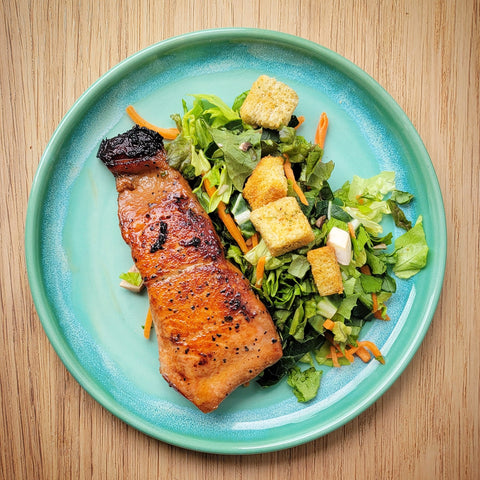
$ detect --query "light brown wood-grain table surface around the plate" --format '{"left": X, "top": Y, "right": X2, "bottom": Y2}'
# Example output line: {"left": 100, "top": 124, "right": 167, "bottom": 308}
{"left": 0, "top": 0, "right": 480, "bottom": 480}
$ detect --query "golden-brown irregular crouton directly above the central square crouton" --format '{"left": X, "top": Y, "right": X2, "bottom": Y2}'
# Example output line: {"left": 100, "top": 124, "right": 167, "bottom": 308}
{"left": 243, "top": 155, "right": 288, "bottom": 210}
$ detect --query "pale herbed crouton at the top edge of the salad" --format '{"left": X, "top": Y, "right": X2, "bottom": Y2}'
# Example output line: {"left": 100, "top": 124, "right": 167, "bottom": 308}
{"left": 240, "top": 75, "right": 298, "bottom": 130}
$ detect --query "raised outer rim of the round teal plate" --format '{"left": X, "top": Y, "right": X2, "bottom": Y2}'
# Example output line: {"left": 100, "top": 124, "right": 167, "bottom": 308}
{"left": 24, "top": 27, "right": 447, "bottom": 454}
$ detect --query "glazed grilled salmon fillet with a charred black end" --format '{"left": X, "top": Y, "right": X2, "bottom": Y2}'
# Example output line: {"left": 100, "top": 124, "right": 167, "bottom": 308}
{"left": 97, "top": 126, "right": 282, "bottom": 413}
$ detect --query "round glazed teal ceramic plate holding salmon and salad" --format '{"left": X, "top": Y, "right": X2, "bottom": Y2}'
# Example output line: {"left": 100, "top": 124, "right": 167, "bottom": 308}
{"left": 26, "top": 29, "right": 446, "bottom": 454}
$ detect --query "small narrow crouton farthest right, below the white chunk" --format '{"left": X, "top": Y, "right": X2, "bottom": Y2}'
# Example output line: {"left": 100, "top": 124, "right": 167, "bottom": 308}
{"left": 307, "top": 246, "right": 343, "bottom": 297}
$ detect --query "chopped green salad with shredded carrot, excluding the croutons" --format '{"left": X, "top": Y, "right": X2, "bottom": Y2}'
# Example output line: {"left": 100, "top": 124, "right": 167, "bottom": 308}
{"left": 123, "top": 86, "right": 428, "bottom": 402}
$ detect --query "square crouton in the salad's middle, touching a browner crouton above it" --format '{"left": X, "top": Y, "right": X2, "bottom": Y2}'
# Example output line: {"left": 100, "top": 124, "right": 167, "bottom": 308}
{"left": 250, "top": 197, "right": 315, "bottom": 257}
